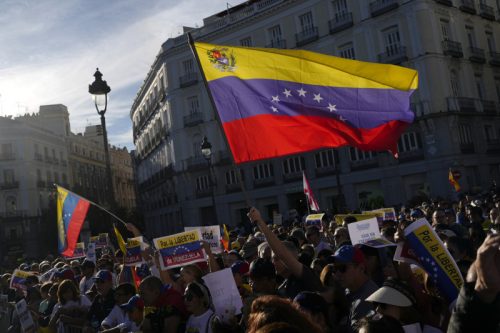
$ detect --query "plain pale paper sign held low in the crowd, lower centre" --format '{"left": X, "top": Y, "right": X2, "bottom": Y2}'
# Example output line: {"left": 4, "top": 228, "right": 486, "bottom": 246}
{"left": 203, "top": 268, "right": 243, "bottom": 321}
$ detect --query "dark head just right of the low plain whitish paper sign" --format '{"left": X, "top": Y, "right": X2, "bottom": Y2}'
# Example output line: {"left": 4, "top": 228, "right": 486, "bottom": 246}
{"left": 249, "top": 258, "right": 277, "bottom": 294}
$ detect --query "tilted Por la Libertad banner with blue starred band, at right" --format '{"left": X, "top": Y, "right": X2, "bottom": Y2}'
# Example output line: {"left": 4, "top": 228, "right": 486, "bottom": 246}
{"left": 404, "top": 219, "right": 464, "bottom": 303}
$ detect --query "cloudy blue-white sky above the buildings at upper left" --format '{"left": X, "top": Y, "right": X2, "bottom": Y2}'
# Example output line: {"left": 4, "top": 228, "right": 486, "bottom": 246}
{"left": 0, "top": 0, "right": 237, "bottom": 150}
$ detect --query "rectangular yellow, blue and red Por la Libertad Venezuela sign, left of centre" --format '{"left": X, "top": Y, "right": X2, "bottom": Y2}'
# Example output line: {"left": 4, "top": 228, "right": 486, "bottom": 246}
{"left": 153, "top": 230, "right": 206, "bottom": 270}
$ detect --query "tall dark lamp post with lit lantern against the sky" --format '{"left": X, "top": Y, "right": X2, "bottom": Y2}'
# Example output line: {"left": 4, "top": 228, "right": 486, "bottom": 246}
{"left": 89, "top": 68, "right": 116, "bottom": 208}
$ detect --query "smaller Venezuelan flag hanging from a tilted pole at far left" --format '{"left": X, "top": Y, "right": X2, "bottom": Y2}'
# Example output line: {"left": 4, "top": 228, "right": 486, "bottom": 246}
{"left": 57, "top": 186, "right": 90, "bottom": 257}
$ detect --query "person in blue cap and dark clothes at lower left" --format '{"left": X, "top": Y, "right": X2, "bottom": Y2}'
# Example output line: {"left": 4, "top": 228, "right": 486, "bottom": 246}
{"left": 87, "top": 270, "right": 115, "bottom": 330}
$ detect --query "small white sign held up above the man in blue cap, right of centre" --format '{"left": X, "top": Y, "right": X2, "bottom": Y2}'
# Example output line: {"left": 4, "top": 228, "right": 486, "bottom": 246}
{"left": 347, "top": 217, "right": 396, "bottom": 248}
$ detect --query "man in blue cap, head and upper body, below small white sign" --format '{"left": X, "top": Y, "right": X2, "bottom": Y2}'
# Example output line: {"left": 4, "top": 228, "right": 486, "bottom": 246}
{"left": 331, "top": 245, "right": 378, "bottom": 328}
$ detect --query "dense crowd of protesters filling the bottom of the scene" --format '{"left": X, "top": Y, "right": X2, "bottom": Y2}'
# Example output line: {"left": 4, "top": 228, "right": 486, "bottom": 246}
{"left": 0, "top": 188, "right": 500, "bottom": 333}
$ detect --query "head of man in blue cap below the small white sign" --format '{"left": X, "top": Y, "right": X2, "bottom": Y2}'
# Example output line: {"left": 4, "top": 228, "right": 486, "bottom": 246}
{"left": 332, "top": 245, "right": 368, "bottom": 292}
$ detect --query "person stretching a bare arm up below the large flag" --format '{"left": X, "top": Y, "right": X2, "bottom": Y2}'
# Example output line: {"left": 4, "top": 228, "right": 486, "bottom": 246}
{"left": 248, "top": 207, "right": 323, "bottom": 299}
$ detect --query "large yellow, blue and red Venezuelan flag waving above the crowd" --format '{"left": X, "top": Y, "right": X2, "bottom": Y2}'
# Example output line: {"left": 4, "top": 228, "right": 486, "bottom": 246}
{"left": 194, "top": 42, "right": 418, "bottom": 163}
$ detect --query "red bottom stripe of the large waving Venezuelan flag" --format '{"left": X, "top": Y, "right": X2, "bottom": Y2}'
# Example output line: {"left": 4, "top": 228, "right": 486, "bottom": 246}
{"left": 223, "top": 115, "right": 409, "bottom": 163}
